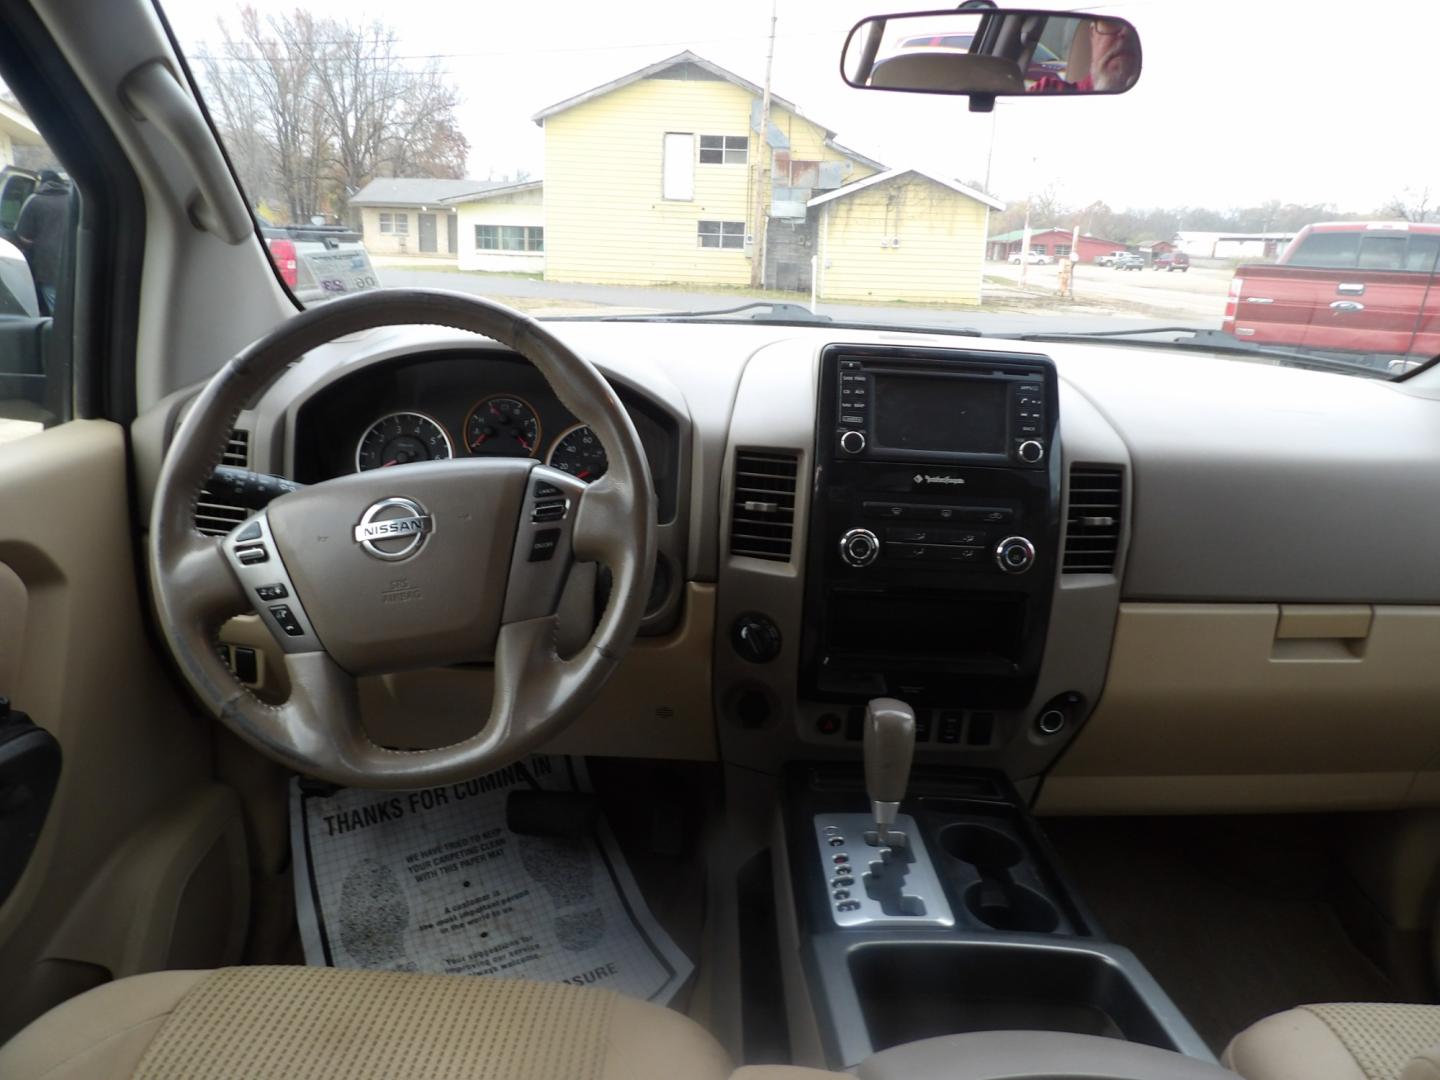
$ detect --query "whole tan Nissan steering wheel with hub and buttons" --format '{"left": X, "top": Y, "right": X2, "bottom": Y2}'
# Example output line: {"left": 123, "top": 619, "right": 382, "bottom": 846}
{"left": 150, "top": 289, "right": 655, "bottom": 788}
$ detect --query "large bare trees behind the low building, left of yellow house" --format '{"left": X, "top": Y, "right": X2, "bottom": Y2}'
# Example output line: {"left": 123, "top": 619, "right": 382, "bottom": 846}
{"left": 200, "top": 7, "right": 469, "bottom": 222}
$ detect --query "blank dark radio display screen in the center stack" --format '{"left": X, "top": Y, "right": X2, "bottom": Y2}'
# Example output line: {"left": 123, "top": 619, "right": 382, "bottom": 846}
{"left": 873, "top": 373, "right": 1009, "bottom": 454}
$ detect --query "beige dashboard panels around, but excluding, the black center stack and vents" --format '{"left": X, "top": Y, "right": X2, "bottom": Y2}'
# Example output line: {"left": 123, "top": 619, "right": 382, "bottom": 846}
{"left": 135, "top": 323, "right": 1440, "bottom": 814}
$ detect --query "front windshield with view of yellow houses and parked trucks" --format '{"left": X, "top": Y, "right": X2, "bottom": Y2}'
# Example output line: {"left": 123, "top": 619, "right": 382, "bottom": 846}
{"left": 164, "top": 0, "right": 1440, "bottom": 376}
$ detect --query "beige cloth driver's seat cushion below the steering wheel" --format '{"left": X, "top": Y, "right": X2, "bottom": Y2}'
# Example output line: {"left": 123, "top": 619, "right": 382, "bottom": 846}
{"left": 0, "top": 966, "right": 835, "bottom": 1080}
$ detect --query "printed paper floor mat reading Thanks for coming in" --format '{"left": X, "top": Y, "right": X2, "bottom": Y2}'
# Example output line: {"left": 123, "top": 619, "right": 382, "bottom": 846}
{"left": 291, "top": 756, "right": 694, "bottom": 1004}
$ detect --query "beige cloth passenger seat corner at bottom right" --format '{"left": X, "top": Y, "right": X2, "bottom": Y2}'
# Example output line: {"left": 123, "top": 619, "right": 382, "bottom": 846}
{"left": 1223, "top": 1002, "right": 1440, "bottom": 1080}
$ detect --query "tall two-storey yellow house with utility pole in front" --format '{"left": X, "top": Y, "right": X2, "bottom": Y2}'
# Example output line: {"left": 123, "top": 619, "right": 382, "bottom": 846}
{"left": 534, "top": 52, "right": 883, "bottom": 288}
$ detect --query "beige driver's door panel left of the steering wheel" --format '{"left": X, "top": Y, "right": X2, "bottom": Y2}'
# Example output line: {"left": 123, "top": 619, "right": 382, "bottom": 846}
{"left": 0, "top": 420, "right": 249, "bottom": 1041}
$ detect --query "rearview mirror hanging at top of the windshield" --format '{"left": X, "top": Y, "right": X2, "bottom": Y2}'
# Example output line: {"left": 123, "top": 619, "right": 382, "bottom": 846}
{"left": 840, "top": 7, "right": 1140, "bottom": 111}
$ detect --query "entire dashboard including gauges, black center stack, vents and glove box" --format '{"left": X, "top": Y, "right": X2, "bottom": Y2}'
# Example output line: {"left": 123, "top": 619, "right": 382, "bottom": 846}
{"left": 135, "top": 323, "right": 1440, "bottom": 814}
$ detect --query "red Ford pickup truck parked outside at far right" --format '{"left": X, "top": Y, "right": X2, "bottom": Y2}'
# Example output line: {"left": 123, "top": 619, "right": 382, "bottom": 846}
{"left": 1220, "top": 222, "right": 1440, "bottom": 363}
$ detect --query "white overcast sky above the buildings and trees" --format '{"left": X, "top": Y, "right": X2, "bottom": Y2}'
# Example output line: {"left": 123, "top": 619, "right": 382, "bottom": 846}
{"left": 163, "top": 0, "right": 1440, "bottom": 212}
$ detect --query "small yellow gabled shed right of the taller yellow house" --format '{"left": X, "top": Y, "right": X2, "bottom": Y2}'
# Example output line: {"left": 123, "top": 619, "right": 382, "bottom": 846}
{"left": 808, "top": 168, "right": 1005, "bottom": 305}
